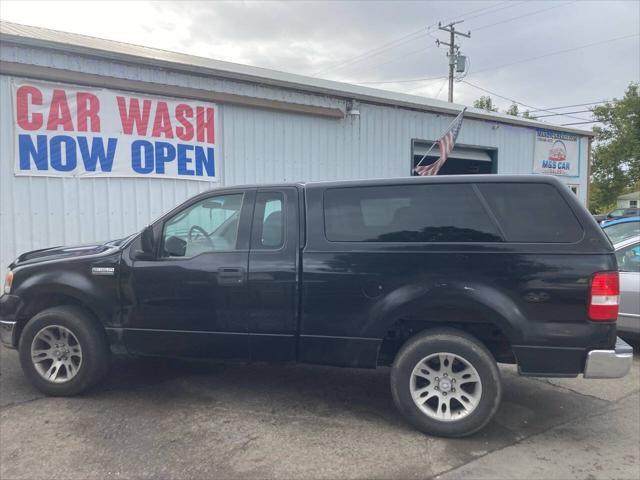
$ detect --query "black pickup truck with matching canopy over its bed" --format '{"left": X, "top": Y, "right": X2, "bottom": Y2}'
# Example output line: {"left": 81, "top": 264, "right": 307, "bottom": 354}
{"left": 0, "top": 175, "right": 632, "bottom": 436}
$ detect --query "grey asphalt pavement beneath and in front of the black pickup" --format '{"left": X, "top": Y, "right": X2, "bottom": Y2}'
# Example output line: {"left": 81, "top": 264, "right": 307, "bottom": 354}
{"left": 0, "top": 348, "right": 640, "bottom": 480}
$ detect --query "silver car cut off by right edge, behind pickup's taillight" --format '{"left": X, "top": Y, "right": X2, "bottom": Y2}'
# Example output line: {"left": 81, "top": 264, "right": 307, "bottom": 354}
{"left": 615, "top": 235, "right": 640, "bottom": 341}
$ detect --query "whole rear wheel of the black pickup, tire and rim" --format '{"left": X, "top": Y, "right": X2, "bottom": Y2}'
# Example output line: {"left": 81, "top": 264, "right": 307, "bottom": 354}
{"left": 391, "top": 329, "right": 502, "bottom": 437}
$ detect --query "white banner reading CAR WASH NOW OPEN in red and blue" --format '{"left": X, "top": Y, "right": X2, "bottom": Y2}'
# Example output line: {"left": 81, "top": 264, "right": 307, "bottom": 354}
{"left": 12, "top": 80, "right": 217, "bottom": 181}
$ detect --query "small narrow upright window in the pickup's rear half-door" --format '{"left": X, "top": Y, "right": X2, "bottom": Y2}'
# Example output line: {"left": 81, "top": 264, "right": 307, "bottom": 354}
{"left": 251, "top": 192, "right": 284, "bottom": 250}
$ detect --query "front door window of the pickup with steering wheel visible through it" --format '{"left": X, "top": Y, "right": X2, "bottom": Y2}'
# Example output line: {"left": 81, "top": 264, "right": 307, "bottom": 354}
{"left": 162, "top": 193, "right": 243, "bottom": 257}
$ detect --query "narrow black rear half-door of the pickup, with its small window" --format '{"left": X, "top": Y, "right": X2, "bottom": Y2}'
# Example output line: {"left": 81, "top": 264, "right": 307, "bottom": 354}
{"left": 247, "top": 187, "right": 300, "bottom": 361}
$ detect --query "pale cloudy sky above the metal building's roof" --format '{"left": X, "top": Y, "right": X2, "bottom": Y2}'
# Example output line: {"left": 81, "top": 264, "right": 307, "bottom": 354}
{"left": 0, "top": 0, "right": 640, "bottom": 127}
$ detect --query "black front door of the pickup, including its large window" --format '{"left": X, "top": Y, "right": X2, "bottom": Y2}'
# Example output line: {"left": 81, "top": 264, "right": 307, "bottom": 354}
{"left": 123, "top": 189, "right": 255, "bottom": 359}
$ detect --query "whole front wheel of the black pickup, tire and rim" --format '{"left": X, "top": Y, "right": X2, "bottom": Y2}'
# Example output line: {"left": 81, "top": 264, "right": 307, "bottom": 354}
{"left": 18, "top": 305, "right": 110, "bottom": 396}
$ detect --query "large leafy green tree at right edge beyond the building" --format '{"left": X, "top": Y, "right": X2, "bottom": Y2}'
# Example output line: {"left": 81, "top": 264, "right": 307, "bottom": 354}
{"left": 589, "top": 83, "right": 640, "bottom": 212}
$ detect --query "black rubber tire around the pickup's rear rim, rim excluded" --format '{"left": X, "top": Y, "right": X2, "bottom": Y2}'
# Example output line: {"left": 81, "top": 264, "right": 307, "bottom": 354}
{"left": 391, "top": 329, "right": 502, "bottom": 437}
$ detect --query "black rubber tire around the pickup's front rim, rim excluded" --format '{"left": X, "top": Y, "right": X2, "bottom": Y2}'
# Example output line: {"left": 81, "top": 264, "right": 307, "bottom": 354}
{"left": 18, "top": 305, "right": 111, "bottom": 396}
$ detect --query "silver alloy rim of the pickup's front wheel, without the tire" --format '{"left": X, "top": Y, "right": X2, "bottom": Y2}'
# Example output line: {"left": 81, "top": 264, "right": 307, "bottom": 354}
{"left": 31, "top": 325, "right": 82, "bottom": 383}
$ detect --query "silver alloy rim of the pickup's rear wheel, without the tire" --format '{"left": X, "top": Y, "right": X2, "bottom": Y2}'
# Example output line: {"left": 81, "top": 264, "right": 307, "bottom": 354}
{"left": 409, "top": 352, "right": 482, "bottom": 422}
